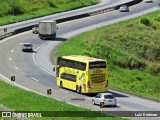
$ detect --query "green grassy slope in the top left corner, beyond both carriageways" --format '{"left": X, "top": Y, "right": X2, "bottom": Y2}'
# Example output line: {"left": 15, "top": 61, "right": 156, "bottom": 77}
{"left": 0, "top": 0, "right": 98, "bottom": 25}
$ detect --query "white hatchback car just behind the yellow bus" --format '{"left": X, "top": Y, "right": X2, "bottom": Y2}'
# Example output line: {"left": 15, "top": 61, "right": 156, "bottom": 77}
{"left": 92, "top": 93, "right": 117, "bottom": 107}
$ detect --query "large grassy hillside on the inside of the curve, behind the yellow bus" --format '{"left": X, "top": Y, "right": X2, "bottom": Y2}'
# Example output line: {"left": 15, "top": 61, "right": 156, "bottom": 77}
{"left": 55, "top": 11, "right": 160, "bottom": 100}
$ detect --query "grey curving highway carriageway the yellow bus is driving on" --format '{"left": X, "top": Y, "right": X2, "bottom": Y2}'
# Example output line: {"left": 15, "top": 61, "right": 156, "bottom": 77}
{"left": 0, "top": 1, "right": 160, "bottom": 119}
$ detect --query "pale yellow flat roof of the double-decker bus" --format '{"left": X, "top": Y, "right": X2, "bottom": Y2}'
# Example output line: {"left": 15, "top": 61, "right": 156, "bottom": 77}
{"left": 62, "top": 55, "right": 106, "bottom": 63}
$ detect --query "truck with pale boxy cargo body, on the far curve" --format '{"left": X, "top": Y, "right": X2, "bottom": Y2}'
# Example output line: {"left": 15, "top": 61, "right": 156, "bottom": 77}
{"left": 39, "top": 20, "right": 58, "bottom": 39}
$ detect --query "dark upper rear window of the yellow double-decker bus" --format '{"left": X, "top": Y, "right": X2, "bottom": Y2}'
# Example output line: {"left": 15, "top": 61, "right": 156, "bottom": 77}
{"left": 89, "top": 61, "right": 106, "bottom": 69}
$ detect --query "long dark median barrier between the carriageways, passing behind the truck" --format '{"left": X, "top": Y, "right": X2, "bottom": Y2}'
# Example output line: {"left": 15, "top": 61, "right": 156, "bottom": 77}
{"left": 0, "top": 0, "right": 143, "bottom": 40}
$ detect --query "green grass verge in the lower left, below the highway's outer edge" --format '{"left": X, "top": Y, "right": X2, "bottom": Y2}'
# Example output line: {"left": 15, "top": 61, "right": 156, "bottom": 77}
{"left": 0, "top": 80, "right": 124, "bottom": 120}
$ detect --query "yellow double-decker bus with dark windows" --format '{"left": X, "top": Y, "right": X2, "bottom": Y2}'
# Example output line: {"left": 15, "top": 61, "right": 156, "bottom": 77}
{"left": 53, "top": 55, "right": 108, "bottom": 94}
